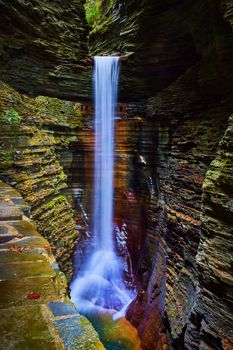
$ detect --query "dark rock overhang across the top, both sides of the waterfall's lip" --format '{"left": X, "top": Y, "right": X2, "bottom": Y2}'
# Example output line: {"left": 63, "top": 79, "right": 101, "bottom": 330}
{"left": 0, "top": 0, "right": 232, "bottom": 101}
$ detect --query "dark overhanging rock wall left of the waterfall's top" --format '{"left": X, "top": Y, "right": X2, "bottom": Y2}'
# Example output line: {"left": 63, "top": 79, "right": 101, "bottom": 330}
{"left": 0, "top": 0, "right": 91, "bottom": 100}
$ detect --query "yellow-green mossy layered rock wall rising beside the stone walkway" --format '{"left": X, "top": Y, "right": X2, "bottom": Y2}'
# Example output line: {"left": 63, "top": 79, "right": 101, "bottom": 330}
{"left": 0, "top": 83, "right": 82, "bottom": 276}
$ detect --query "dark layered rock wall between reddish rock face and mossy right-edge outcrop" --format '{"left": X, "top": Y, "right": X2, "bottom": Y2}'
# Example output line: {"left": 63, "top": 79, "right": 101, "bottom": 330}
{"left": 144, "top": 39, "right": 232, "bottom": 349}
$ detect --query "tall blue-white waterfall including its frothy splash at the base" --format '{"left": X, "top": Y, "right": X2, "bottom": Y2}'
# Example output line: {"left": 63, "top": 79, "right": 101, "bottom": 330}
{"left": 70, "top": 57, "right": 133, "bottom": 318}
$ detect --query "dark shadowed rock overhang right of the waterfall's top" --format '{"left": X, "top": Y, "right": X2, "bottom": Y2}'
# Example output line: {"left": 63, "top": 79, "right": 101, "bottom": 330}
{"left": 89, "top": 0, "right": 232, "bottom": 101}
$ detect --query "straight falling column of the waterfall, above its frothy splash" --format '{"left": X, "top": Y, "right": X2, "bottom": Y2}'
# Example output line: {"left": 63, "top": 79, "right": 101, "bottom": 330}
{"left": 94, "top": 57, "right": 119, "bottom": 252}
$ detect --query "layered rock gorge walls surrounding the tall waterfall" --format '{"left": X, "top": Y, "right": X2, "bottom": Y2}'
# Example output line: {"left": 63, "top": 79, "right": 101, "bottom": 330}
{"left": 0, "top": 0, "right": 233, "bottom": 350}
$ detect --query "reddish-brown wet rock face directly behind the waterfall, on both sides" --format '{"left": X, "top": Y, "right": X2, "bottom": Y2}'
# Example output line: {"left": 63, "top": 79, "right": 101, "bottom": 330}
{"left": 65, "top": 105, "right": 169, "bottom": 349}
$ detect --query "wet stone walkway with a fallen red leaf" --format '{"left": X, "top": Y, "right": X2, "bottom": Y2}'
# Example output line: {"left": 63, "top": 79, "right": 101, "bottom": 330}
{"left": 0, "top": 181, "right": 105, "bottom": 350}
